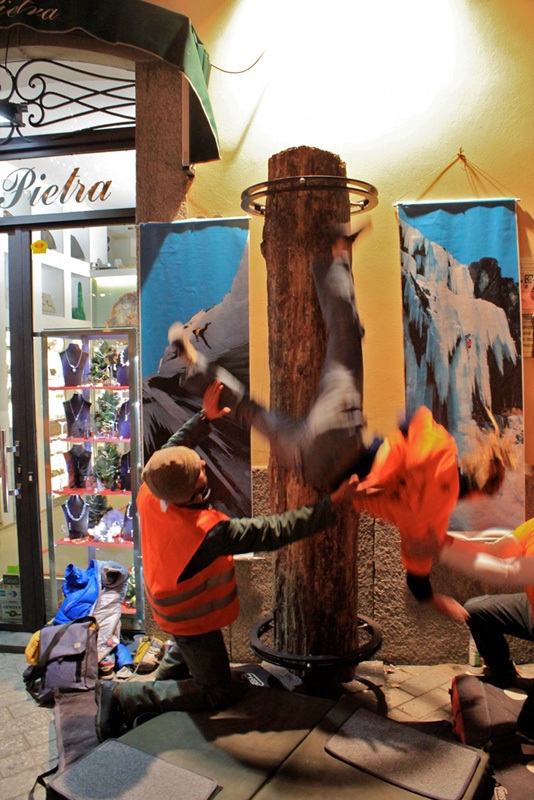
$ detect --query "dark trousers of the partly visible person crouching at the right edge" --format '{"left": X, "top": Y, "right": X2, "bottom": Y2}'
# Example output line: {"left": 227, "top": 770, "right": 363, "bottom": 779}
{"left": 465, "top": 592, "right": 534, "bottom": 739}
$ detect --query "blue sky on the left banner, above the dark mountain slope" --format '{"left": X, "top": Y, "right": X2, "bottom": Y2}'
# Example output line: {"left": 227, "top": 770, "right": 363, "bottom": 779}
{"left": 140, "top": 217, "right": 249, "bottom": 376}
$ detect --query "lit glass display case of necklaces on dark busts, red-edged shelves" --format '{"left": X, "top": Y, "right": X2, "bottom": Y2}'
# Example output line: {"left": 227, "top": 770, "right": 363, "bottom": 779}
{"left": 41, "top": 328, "right": 144, "bottom": 619}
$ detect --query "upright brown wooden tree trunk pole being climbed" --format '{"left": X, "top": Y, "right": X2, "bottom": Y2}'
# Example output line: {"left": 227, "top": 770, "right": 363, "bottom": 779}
{"left": 262, "top": 147, "right": 364, "bottom": 682}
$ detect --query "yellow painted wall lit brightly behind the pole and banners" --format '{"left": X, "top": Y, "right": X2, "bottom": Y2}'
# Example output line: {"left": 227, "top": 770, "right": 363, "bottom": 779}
{"left": 148, "top": 0, "right": 534, "bottom": 466}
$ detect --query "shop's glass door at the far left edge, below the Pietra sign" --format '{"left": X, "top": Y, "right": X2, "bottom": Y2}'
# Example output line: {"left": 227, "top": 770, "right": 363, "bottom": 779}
{"left": 0, "top": 229, "right": 45, "bottom": 630}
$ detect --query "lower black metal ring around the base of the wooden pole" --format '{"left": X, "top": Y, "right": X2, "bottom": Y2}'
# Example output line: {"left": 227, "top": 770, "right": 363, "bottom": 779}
{"left": 249, "top": 614, "right": 382, "bottom": 671}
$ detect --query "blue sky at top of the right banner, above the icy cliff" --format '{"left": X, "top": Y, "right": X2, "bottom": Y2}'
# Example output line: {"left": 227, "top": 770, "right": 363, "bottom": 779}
{"left": 398, "top": 200, "right": 519, "bottom": 281}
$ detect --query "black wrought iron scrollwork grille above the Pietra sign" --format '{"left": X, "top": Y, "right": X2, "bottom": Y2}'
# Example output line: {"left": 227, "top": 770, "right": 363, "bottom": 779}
{"left": 0, "top": 59, "right": 135, "bottom": 146}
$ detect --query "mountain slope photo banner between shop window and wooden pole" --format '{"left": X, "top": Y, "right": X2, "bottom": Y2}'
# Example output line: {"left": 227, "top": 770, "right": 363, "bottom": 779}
{"left": 140, "top": 217, "right": 251, "bottom": 516}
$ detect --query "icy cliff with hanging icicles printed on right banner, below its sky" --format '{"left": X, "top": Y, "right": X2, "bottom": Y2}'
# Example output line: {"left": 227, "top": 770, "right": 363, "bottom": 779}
{"left": 399, "top": 220, "right": 524, "bottom": 530}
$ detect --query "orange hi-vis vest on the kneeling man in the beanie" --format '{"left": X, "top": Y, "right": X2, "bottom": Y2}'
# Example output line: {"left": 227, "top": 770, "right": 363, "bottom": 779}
{"left": 137, "top": 484, "right": 239, "bottom": 636}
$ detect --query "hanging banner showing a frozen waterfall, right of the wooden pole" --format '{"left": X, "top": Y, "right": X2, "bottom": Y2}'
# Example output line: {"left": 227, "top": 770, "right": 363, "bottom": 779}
{"left": 397, "top": 199, "right": 525, "bottom": 530}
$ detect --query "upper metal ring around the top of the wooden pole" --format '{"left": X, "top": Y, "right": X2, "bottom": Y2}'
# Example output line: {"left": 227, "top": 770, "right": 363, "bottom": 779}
{"left": 241, "top": 175, "right": 378, "bottom": 216}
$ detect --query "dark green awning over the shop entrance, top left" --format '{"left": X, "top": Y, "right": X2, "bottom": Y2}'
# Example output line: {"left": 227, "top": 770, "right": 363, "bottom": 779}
{"left": 0, "top": 0, "right": 220, "bottom": 163}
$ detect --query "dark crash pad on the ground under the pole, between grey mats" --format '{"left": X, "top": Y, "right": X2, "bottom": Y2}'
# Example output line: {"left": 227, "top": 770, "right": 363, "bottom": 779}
{"left": 120, "top": 687, "right": 488, "bottom": 800}
